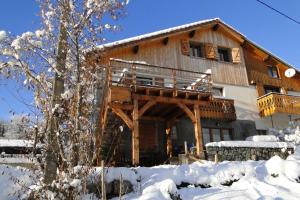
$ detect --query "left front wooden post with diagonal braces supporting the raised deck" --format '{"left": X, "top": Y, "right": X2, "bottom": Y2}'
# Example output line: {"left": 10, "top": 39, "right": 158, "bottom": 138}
{"left": 132, "top": 99, "right": 140, "bottom": 166}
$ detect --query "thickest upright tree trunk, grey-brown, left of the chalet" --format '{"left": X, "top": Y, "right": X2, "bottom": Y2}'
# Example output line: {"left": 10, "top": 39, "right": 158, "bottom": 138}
{"left": 44, "top": 1, "right": 70, "bottom": 184}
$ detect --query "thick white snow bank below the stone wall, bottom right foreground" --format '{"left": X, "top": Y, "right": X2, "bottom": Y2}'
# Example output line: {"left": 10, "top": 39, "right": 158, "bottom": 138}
{"left": 108, "top": 156, "right": 300, "bottom": 200}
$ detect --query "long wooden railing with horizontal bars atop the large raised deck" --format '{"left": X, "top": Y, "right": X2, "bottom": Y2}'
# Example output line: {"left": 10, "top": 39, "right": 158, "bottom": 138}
{"left": 109, "top": 59, "right": 212, "bottom": 93}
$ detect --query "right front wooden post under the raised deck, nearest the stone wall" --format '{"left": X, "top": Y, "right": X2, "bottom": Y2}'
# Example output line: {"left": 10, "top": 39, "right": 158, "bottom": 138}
{"left": 194, "top": 105, "right": 203, "bottom": 157}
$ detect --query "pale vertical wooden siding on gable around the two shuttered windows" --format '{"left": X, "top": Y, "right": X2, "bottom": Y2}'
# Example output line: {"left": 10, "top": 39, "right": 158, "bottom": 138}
{"left": 102, "top": 29, "right": 248, "bottom": 86}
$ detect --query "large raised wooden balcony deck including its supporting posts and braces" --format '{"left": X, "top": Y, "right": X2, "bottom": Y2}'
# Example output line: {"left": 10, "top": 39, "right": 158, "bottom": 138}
{"left": 97, "top": 60, "right": 236, "bottom": 165}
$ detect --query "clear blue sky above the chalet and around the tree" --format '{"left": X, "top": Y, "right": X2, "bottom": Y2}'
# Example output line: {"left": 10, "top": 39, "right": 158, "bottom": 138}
{"left": 0, "top": 0, "right": 300, "bottom": 119}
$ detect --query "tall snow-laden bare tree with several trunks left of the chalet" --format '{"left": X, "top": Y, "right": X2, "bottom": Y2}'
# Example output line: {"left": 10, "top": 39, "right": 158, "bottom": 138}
{"left": 0, "top": 0, "right": 128, "bottom": 184}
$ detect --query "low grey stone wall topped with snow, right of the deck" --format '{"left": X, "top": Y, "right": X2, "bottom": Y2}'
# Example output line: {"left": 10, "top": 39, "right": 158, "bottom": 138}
{"left": 206, "top": 146, "right": 294, "bottom": 161}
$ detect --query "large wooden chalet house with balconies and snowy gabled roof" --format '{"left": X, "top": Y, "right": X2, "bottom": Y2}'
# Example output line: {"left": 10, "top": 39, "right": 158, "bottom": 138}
{"left": 88, "top": 18, "right": 300, "bottom": 165}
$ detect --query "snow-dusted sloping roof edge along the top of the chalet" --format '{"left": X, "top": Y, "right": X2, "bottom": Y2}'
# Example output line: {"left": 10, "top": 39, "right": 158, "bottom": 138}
{"left": 92, "top": 18, "right": 299, "bottom": 72}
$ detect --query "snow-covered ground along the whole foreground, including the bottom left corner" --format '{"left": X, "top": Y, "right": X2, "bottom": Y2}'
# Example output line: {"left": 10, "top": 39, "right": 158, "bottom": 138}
{"left": 0, "top": 151, "right": 300, "bottom": 200}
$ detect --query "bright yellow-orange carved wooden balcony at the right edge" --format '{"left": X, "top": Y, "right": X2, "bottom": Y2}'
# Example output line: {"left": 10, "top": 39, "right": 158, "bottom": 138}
{"left": 257, "top": 93, "right": 300, "bottom": 117}
